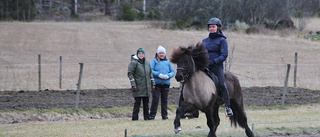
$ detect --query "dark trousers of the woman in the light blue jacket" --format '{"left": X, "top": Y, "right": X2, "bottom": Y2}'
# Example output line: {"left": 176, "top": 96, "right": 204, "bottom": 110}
{"left": 150, "top": 84, "right": 169, "bottom": 118}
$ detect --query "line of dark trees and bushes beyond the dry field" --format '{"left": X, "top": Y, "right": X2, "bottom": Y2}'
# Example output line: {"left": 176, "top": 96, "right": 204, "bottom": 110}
{"left": 0, "top": 0, "right": 320, "bottom": 28}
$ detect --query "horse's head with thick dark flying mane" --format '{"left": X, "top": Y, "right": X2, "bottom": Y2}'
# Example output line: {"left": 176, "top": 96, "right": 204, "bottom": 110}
{"left": 170, "top": 43, "right": 208, "bottom": 83}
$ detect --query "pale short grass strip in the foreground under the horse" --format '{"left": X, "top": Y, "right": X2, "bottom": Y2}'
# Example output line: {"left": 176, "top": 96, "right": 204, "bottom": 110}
{"left": 0, "top": 104, "right": 320, "bottom": 137}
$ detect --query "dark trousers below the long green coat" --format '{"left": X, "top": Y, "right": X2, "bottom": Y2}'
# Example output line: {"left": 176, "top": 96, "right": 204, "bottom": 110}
{"left": 132, "top": 97, "right": 149, "bottom": 120}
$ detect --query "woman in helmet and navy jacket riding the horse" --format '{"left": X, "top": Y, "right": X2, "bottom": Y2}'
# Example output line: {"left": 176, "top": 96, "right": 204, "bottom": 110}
{"left": 202, "top": 18, "right": 233, "bottom": 117}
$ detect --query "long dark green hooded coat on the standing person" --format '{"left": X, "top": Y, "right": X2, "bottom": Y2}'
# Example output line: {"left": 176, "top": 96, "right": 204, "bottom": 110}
{"left": 128, "top": 54, "right": 155, "bottom": 97}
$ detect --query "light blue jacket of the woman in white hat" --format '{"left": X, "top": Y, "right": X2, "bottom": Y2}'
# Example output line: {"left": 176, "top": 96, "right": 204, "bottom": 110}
{"left": 150, "top": 58, "right": 175, "bottom": 86}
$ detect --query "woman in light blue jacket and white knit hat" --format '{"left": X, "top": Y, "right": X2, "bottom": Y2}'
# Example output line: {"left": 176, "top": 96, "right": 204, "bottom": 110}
{"left": 150, "top": 45, "right": 175, "bottom": 120}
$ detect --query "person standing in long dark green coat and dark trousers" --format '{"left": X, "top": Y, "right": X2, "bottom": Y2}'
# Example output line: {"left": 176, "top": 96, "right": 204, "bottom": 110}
{"left": 128, "top": 48, "right": 155, "bottom": 121}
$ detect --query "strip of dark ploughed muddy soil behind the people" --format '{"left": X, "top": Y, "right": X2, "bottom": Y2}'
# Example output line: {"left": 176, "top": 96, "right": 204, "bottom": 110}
{"left": 0, "top": 87, "right": 320, "bottom": 110}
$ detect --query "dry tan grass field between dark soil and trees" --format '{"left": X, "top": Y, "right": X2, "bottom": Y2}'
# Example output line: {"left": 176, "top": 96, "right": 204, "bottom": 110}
{"left": 0, "top": 19, "right": 320, "bottom": 91}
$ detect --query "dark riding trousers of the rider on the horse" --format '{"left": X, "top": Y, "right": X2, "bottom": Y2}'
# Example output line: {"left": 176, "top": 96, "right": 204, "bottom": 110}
{"left": 209, "top": 66, "right": 230, "bottom": 107}
